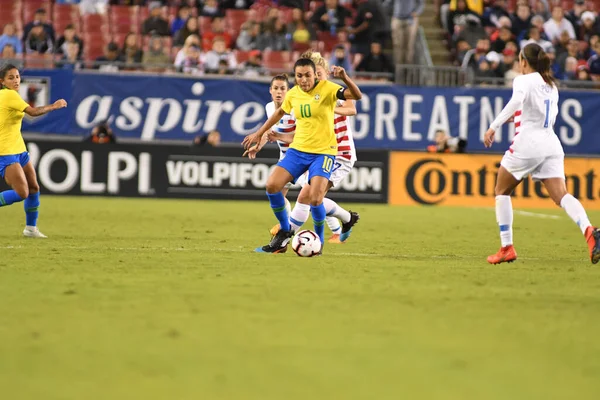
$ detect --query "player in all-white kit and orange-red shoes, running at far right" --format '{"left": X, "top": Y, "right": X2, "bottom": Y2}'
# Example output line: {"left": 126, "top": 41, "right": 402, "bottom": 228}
{"left": 484, "top": 43, "right": 600, "bottom": 264}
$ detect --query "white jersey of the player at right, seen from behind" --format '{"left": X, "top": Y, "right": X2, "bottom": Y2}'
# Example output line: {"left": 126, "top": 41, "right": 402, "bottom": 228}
{"left": 490, "top": 72, "right": 564, "bottom": 158}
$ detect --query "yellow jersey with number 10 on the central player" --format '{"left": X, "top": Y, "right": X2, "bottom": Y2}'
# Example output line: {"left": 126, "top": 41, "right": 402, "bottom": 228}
{"left": 281, "top": 81, "right": 342, "bottom": 156}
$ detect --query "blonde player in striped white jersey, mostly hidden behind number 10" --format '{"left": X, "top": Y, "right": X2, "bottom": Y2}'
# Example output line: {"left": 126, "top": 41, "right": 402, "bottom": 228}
{"left": 269, "top": 51, "right": 360, "bottom": 243}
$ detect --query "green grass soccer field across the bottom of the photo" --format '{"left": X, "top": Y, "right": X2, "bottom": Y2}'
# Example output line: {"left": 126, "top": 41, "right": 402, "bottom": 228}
{"left": 0, "top": 197, "right": 600, "bottom": 400}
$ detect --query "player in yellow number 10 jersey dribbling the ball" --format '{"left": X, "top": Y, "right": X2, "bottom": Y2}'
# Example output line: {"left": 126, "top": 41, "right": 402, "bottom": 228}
{"left": 242, "top": 58, "right": 362, "bottom": 253}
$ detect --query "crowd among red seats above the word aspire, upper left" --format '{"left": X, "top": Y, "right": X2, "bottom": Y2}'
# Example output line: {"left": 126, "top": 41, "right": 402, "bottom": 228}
{"left": 0, "top": 0, "right": 403, "bottom": 76}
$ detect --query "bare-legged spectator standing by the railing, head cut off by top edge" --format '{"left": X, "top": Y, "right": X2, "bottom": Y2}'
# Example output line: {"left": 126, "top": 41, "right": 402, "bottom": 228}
{"left": 392, "top": 0, "right": 425, "bottom": 64}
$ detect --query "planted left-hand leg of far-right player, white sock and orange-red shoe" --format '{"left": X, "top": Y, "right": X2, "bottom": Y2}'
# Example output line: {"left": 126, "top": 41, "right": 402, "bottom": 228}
{"left": 487, "top": 166, "right": 520, "bottom": 264}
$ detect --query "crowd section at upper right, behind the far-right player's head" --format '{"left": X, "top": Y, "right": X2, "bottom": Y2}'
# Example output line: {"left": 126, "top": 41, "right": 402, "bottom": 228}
{"left": 438, "top": 0, "right": 600, "bottom": 86}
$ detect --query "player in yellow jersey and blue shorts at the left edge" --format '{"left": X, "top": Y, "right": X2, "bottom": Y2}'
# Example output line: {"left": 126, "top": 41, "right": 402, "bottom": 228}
{"left": 0, "top": 64, "right": 67, "bottom": 238}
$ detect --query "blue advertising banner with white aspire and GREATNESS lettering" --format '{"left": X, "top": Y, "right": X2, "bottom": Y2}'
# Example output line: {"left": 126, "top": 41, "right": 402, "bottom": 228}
{"left": 21, "top": 71, "right": 600, "bottom": 154}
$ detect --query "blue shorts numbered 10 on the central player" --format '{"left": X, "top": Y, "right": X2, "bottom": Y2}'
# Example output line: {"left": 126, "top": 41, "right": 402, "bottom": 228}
{"left": 277, "top": 149, "right": 335, "bottom": 182}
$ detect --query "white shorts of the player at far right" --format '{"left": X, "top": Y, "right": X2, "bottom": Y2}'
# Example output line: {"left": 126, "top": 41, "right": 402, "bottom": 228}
{"left": 500, "top": 151, "right": 565, "bottom": 181}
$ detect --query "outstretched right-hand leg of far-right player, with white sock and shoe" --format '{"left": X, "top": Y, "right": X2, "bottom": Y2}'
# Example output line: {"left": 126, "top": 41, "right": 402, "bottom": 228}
{"left": 542, "top": 178, "right": 600, "bottom": 264}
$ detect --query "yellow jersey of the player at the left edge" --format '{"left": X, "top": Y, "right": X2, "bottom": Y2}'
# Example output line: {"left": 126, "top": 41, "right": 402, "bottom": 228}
{"left": 0, "top": 89, "right": 29, "bottom": 156}
